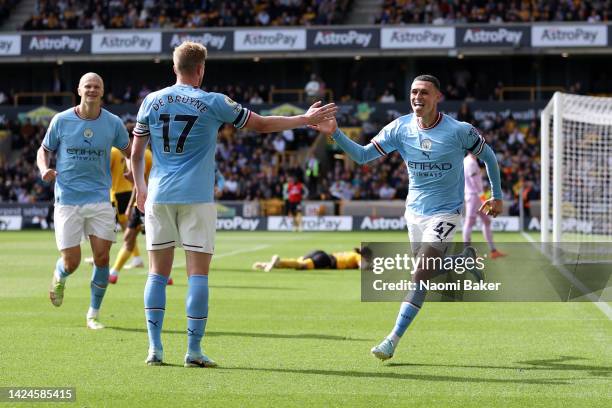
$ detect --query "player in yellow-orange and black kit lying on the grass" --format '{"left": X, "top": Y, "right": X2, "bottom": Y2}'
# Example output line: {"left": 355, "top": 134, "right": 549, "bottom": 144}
{"left": 253, "top": 248, "right": 361, "bottom": 272}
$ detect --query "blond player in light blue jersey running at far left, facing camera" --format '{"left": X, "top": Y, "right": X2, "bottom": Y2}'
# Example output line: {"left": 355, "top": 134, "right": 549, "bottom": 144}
{"left": 37, "top": 72, "right": 130, "bottom": 330}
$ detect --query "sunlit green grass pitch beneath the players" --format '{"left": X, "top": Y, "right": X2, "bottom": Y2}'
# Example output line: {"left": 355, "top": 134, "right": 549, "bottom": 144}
{"left": 0, "top": 232, "right": 612, "bottom": 408}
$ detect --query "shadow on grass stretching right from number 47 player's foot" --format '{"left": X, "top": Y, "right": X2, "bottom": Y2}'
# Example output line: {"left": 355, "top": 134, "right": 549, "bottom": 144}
{"left": 387, "top": 356, "right": 612, "bottom": 377}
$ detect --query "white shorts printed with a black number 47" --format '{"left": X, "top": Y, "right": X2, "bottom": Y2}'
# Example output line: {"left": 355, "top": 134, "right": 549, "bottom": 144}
{"left": 404, "top": 210, "right": 461, "bottom": 254}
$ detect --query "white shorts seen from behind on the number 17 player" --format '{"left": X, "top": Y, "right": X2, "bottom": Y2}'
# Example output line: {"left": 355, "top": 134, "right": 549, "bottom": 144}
{"left": 144, "top": 203, "right": 217, "bottom": 254}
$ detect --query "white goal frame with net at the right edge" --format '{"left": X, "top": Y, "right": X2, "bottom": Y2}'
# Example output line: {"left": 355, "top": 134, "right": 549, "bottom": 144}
{"left": 540, "top": 92, "right": 612, "bottom": 243}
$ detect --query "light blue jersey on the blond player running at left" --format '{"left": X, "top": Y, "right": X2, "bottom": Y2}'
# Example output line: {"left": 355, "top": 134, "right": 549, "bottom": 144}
{"left": 42, "top": 108, "right": 130, "bottom": 205}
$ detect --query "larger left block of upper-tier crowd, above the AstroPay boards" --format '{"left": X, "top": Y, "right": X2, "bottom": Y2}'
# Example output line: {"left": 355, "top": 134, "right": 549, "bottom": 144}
{"left": 23, "top": 0, "right": 350, "bottom": 30}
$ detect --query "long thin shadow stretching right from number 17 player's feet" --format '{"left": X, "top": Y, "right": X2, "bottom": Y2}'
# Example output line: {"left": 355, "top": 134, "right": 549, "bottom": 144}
{"left": 217, "top": 367, "right": 570, "bottom": 385}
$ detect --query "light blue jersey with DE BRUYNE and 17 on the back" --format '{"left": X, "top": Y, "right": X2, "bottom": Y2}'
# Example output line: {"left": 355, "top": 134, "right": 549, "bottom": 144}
{"left": 134, "top": 84, "right": 251, "bottom": 204}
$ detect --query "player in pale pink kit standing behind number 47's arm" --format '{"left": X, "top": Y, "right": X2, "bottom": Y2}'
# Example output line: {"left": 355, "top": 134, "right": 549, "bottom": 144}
{"left": 463, "top": 153, "right": 506, "bottom": 259}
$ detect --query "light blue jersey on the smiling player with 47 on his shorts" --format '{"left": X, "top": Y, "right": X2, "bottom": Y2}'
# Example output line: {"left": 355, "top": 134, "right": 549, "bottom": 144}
{"left": 372, "top": 113, "right": 486, "bottom": 215}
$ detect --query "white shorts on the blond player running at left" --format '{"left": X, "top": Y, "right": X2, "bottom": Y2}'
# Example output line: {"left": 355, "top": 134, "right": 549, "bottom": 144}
{"left": 53, "top": 202, "right": 117, "bottom": 251}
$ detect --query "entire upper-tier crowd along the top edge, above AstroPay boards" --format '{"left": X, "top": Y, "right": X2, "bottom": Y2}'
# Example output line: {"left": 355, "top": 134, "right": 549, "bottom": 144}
{"left": 19, "top": 0, "right": 612, "bottom": 30}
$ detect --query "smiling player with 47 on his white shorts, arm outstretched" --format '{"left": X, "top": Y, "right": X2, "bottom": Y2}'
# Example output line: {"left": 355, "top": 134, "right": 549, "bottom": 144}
{"left": 313, "top": 75, "right": 502, "bottom": 360}
